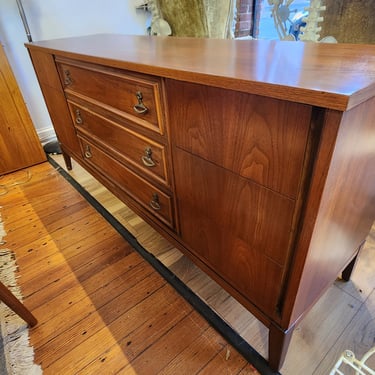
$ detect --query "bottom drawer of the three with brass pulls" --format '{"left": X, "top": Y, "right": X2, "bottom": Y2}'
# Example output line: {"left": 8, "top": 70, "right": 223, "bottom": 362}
{"left": 79, "top": 136, "right": 174, "bottom": 229}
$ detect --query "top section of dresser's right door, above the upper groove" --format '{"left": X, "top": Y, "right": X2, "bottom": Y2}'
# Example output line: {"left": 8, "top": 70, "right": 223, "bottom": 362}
{"left": 166, "top": 80, "right": 311, "bottom": 198}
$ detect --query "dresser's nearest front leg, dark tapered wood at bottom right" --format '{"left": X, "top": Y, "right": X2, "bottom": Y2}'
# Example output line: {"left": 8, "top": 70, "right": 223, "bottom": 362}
{"left": 268, "top": 323, "right": 294, "bottom": 371}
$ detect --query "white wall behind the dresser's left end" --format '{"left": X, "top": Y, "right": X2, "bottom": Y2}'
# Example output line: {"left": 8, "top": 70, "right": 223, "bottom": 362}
{"left": 0, "top": 0, "right": 150, "bottom": 142}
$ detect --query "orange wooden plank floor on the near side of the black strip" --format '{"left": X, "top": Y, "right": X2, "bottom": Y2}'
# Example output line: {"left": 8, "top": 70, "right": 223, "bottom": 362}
{"left": 0, "top": 163, "right": 257, "bottom": 375}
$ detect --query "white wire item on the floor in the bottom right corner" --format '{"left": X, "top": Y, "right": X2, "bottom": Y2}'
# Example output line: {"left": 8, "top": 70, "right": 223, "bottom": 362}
{"left": 329, "top": 346, "right": 375, "bottom": 375}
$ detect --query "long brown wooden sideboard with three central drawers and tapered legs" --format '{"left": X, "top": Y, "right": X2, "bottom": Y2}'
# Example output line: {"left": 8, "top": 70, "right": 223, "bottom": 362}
{"left": 27, "top": 35, "right": 375, "bottom": 369}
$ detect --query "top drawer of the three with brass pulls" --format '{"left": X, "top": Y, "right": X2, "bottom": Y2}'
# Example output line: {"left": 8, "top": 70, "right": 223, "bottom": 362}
{"left": 56, "top": 58, "right": 164, "bottom": 134}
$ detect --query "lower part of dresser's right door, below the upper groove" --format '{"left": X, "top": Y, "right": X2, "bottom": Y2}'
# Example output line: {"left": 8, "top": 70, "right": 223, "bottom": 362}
{"left": 174, "top": 149, "right": 294, "bottom": 314}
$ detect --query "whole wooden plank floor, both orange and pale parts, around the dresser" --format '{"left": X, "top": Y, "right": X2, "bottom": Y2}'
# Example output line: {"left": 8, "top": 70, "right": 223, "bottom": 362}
{"left": 0, "top": 155, "right": 375, "bottom": 375}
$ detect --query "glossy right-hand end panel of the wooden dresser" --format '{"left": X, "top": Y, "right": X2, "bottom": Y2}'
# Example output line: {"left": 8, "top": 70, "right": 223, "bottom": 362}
{"left": 286, "top": 99, "right": 375, "bottom": 328}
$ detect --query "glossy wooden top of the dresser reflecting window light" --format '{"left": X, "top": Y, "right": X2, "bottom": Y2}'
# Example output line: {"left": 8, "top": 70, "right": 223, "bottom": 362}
{"left": 26, "top": 34, "right": 375, "bottom": 110}
